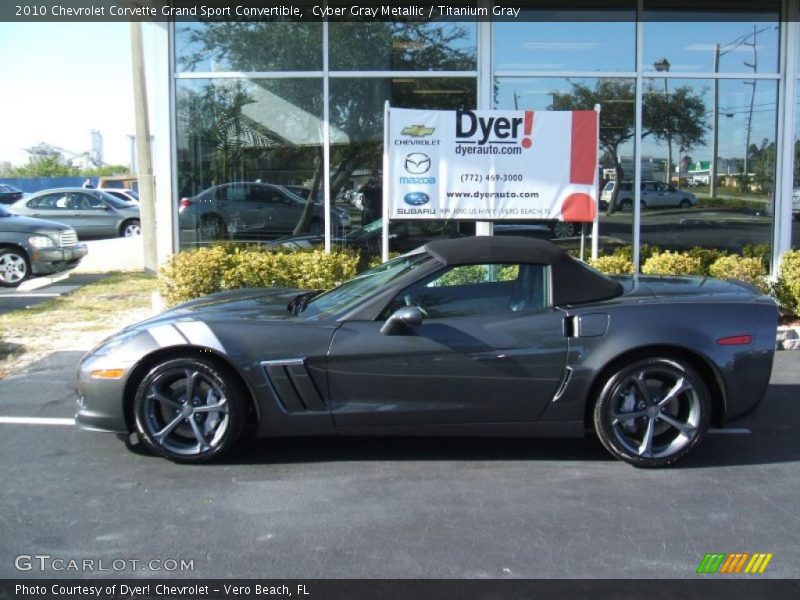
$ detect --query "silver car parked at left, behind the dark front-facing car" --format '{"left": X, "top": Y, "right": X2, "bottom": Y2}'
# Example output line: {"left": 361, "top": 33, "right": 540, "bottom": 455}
{"left": 9, "top": 188, "right": 141, "bottom": 238}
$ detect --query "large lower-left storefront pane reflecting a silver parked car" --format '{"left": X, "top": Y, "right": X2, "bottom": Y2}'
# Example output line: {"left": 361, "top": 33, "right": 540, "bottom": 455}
{"left": 176, "top": 79, "right": 324, "bottom": 248}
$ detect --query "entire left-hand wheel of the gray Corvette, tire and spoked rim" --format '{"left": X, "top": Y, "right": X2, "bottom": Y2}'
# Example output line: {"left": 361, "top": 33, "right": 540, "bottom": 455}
{"left": 133, "top": 357, "right": 247, "bottom": 463}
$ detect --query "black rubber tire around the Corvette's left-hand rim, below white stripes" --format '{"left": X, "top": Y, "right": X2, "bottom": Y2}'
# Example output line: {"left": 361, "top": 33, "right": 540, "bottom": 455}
{"left": 133, "top": 357, "right": 246, "bottom": 463}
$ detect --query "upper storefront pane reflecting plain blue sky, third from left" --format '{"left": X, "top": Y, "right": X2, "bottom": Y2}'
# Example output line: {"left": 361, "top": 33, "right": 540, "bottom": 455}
{"left": 492, "top": 4, "right": 636, "bottom": 72}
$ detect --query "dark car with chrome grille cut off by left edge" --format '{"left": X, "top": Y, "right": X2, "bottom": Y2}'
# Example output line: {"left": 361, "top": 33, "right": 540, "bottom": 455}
{"left": 0, "top": 206, "right": 86, "bottom": 287}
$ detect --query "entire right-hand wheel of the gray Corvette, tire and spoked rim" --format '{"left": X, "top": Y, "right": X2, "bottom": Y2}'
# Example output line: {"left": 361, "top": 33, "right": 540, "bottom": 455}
{"left": 594, "top": 356, "right": 711, "bottom": 468}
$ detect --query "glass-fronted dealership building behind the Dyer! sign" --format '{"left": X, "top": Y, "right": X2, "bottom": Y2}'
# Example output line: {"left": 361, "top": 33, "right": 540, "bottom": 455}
{"left": 144, "top": 0, "right": 800, "bottom": 272}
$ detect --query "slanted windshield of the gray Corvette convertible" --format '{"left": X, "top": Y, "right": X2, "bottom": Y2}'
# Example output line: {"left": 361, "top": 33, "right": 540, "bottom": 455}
{"left": 302, "top": 251, "right": 431, "bottom": 318}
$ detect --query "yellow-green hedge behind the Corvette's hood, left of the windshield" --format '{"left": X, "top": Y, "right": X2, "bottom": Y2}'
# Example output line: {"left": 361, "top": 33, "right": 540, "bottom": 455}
{"left": 160, "top": 244, "right": 359, "bottom": 306}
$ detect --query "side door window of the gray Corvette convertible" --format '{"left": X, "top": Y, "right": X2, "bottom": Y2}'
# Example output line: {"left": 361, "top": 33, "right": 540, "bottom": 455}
{"left": 382, "top": 264, "right": 549, "bottom": 319}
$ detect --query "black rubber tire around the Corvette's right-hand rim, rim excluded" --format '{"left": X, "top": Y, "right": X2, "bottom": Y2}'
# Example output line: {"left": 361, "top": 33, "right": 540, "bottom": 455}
{"left": 594, "top": 356, "right": 711, "bottom": 468}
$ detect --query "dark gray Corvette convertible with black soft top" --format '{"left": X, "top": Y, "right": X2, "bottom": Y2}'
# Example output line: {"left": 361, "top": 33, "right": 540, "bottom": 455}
{"left": 76, "top": 237, "right": 778, "bottom": 467}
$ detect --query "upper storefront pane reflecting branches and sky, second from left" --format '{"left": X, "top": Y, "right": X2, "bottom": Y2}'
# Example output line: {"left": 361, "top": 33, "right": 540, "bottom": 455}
{"left": 329, "top": 22, "right": 478, "bottom": 71}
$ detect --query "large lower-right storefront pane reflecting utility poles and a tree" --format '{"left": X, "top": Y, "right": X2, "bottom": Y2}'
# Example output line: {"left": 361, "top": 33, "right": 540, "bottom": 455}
{"left": 641, "top": 78, "right": 778, "bottom": 254}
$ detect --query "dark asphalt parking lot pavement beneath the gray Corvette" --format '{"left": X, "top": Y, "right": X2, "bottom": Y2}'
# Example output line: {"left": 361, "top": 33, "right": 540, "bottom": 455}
{"left": 0, "top": 352, "right": 800, "bottom": 578}
